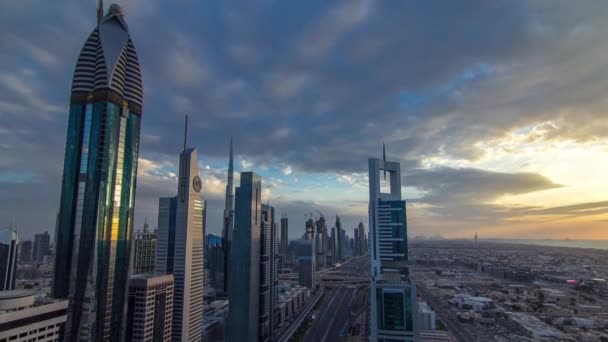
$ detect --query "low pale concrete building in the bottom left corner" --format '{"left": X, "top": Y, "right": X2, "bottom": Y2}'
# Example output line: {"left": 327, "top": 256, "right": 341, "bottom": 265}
{"left": 0, "top": 295, "right": 68, "bottom": 342}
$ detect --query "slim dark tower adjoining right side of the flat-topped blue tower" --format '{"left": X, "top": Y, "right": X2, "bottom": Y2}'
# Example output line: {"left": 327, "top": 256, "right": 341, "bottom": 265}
{"left": 258, "top": 204, "right": 279, "bottom": 341}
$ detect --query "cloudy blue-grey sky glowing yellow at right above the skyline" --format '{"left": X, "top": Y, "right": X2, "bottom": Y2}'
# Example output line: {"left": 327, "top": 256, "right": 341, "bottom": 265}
{"left": 0, "top": 0, "right": 608, "bottom": 239}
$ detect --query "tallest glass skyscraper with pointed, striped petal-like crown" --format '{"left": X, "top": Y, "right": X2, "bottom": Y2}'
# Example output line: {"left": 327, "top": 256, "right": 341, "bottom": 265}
{"left": 52, "top": 1, "right": 143, "bottom": 341}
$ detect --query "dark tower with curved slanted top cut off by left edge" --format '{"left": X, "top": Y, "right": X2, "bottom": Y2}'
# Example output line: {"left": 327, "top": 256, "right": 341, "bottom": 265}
{"left": 0, "top": 226, "right": 19, "bottom": 291}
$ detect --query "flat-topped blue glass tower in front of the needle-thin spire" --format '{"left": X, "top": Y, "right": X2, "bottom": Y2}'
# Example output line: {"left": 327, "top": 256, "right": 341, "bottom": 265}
{"left": 228, "top": 172, "right": 262, "bottom": 342}
